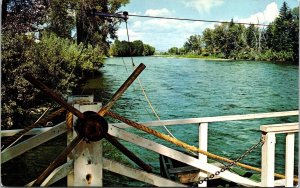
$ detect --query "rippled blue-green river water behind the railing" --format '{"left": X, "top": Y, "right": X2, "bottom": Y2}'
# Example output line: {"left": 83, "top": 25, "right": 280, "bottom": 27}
{"left": 1, "top": 57, "right": 298, "bottom": 186}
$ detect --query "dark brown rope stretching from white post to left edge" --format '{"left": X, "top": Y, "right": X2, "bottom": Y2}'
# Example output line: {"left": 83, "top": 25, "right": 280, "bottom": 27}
{"left": 3, "top": 108, "right": 65, "bottom": 149}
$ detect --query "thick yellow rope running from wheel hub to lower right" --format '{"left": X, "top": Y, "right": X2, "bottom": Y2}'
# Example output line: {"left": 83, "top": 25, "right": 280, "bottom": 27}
{"left": 107, "top": 111, "right": 298, "bottom": 182}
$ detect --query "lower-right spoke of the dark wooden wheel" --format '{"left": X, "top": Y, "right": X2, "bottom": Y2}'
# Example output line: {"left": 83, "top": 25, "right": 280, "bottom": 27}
{"left": 105, "top": 133, "right": 152, "bottom": 172}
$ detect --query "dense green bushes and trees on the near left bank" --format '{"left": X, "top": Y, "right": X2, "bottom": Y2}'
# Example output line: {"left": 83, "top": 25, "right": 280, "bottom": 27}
{"left": 1, "top": 0, "right": 128, "bottom": 128}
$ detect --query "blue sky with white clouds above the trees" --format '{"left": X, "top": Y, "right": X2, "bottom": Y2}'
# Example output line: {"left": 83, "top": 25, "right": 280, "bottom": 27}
{"left": 117, "top": 0, "right": 299, "bottom": 51}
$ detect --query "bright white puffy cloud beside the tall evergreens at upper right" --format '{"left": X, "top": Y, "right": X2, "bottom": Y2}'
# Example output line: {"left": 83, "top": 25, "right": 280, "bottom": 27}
{"left": 238, "top": 2, "right": 279, "bottom": 24}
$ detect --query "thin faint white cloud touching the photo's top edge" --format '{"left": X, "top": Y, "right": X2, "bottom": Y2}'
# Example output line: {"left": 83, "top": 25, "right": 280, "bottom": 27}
{"left": 183, "top": 0, "right": 224, "bottom": 13}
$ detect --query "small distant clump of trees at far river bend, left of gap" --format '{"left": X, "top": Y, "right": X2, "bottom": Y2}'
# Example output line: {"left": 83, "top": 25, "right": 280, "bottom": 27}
{"left": 110, "top": 40, "right": 155, "bottom": 57}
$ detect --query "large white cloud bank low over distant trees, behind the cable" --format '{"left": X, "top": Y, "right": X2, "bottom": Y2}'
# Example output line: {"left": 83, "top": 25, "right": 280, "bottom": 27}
{"left": 117, "top": 8, "right": 205, "bottom": 50}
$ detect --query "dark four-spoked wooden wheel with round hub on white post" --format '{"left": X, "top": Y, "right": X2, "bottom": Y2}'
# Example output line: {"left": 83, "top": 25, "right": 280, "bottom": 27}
{"left": 20, "top": 64, "right": 152, "bottom": 186}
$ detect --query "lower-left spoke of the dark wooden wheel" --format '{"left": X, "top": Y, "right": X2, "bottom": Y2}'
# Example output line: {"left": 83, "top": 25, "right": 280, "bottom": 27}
{"left": 32, "top": 136, "right": 82, "bottom": 186}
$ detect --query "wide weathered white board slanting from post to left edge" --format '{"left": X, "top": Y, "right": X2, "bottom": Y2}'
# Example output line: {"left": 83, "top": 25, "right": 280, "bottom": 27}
{"left": 1, "top": 122, "right": 67, "bottom": 164}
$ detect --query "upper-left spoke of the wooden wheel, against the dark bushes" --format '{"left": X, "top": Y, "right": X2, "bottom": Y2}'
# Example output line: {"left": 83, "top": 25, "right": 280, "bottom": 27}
{"left": 24, "top": 74, "right": 84, "bottom": 119}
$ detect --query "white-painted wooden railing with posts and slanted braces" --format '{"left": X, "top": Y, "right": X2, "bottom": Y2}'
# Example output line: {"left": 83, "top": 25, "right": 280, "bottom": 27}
{"left": 1, "top": 104, "right": 299, "bottom": 187}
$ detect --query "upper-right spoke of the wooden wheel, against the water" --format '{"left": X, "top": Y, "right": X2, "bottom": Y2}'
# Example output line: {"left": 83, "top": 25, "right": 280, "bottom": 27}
{"left": 98, "top": 63, "right": 146, "bottom": 117}
